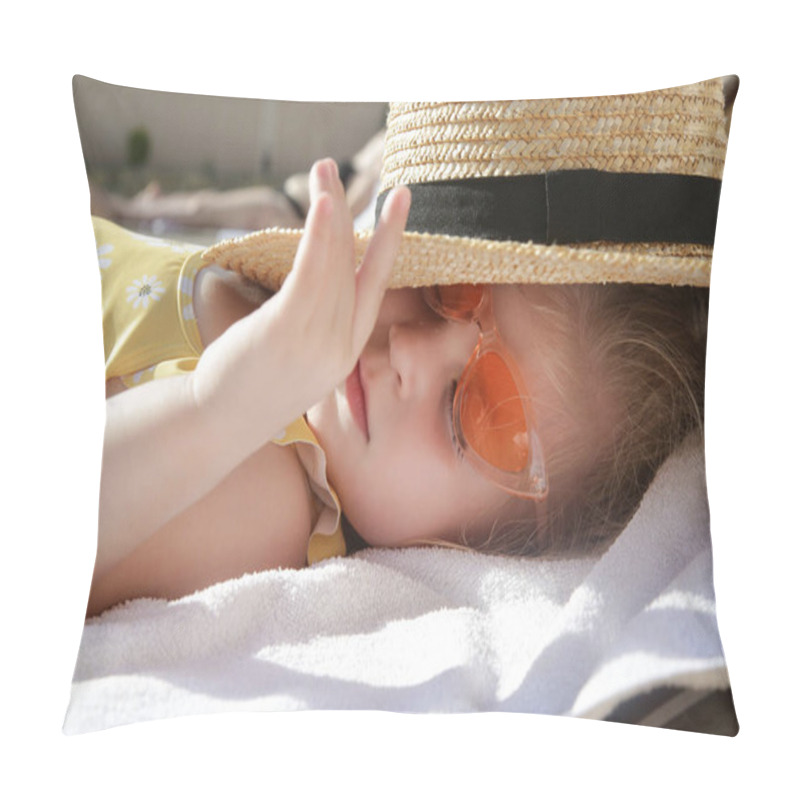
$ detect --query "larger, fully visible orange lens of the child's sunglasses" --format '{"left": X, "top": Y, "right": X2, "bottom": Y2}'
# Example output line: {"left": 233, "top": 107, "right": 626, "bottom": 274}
{"left": 459, "top": 352, "right": 529, "bottom": 472}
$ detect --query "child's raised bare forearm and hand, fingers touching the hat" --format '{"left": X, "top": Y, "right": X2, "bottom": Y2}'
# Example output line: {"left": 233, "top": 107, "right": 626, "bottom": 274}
{"left": 95, "top": 161, "right": 409, "bottom": 575}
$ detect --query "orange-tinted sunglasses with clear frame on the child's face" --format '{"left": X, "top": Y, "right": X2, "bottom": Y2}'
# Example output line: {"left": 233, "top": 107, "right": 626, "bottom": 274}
{"left": 423, "top": 284, "right": 547, "bottom": 500}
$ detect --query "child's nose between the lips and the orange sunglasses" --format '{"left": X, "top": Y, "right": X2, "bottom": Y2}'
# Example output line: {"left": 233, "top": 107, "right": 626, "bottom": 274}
{"left": 389, "top": 320, "right": 478, "bottom": 398}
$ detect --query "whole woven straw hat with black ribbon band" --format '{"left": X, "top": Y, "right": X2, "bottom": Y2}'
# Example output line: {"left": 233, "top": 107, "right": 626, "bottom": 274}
{"left": 204, "top": 79, "right": 727, "bottom": 289}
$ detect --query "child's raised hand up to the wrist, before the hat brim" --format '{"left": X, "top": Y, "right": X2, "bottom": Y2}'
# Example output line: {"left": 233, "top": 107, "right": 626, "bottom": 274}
{"left": 193, "top": 159, "right": 410, "bottom": 448}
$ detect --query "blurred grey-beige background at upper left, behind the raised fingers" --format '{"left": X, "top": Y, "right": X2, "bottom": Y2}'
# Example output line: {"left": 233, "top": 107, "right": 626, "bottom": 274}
{"left": 73, "top": 76, "right": 387, "bottom": 244}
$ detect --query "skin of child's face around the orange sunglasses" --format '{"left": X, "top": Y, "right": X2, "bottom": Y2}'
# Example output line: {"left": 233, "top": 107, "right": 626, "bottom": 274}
{"left": 308, "top": 287, "right": 564, "bottom": 547}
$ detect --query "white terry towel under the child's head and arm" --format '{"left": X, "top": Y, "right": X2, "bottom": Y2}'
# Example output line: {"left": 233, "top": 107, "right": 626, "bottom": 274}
{"left": 65, "top": 438, "right": 729, "bottom": 733}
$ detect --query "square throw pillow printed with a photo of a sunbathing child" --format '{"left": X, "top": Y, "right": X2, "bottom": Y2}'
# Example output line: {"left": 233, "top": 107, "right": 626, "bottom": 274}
{"left": 65, "top": 76, "right": 738, "bottom": 735}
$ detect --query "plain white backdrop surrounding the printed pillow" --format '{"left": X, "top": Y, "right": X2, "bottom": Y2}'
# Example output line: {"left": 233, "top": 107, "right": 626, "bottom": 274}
{"left": 0, "top": 0, "right": 800, "bottom": 798}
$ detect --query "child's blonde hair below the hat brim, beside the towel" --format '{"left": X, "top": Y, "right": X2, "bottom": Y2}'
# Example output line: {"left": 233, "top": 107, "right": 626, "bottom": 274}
{"left": 464, "top": 284, "right": 708, "bottom": 556}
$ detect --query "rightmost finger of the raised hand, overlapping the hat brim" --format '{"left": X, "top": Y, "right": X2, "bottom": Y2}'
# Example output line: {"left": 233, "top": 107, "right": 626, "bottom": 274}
{"left": 353, "top": 186, "right": 411, "bottom": 350}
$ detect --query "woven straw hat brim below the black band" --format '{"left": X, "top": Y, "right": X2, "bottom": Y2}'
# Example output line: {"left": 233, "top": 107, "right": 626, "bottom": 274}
{"left": 203, "top": 229, "right": 711, "bottom": 291}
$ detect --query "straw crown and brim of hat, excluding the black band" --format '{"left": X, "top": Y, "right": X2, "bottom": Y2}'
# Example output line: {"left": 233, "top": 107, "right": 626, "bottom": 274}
{"left": 206, "top": 79, "right": 727, "bottom": 290}
